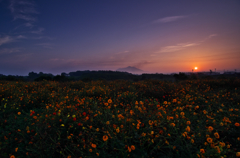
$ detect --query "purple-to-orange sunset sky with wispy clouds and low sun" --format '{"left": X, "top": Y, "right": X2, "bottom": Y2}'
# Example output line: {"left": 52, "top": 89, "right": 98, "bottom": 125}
{"left": 0, "top": 0, "right": 240, "bottom": 75}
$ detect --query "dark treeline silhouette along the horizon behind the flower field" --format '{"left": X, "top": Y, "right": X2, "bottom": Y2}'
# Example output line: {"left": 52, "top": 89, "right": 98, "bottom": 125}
{"left": 0, "top": 70, "right": 240, "bottom": 82}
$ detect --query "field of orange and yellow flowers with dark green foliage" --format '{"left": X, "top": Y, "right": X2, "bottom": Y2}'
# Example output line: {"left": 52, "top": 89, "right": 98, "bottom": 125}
{"left": 0, "top": 79, "right": 240, "bottom": 158}
